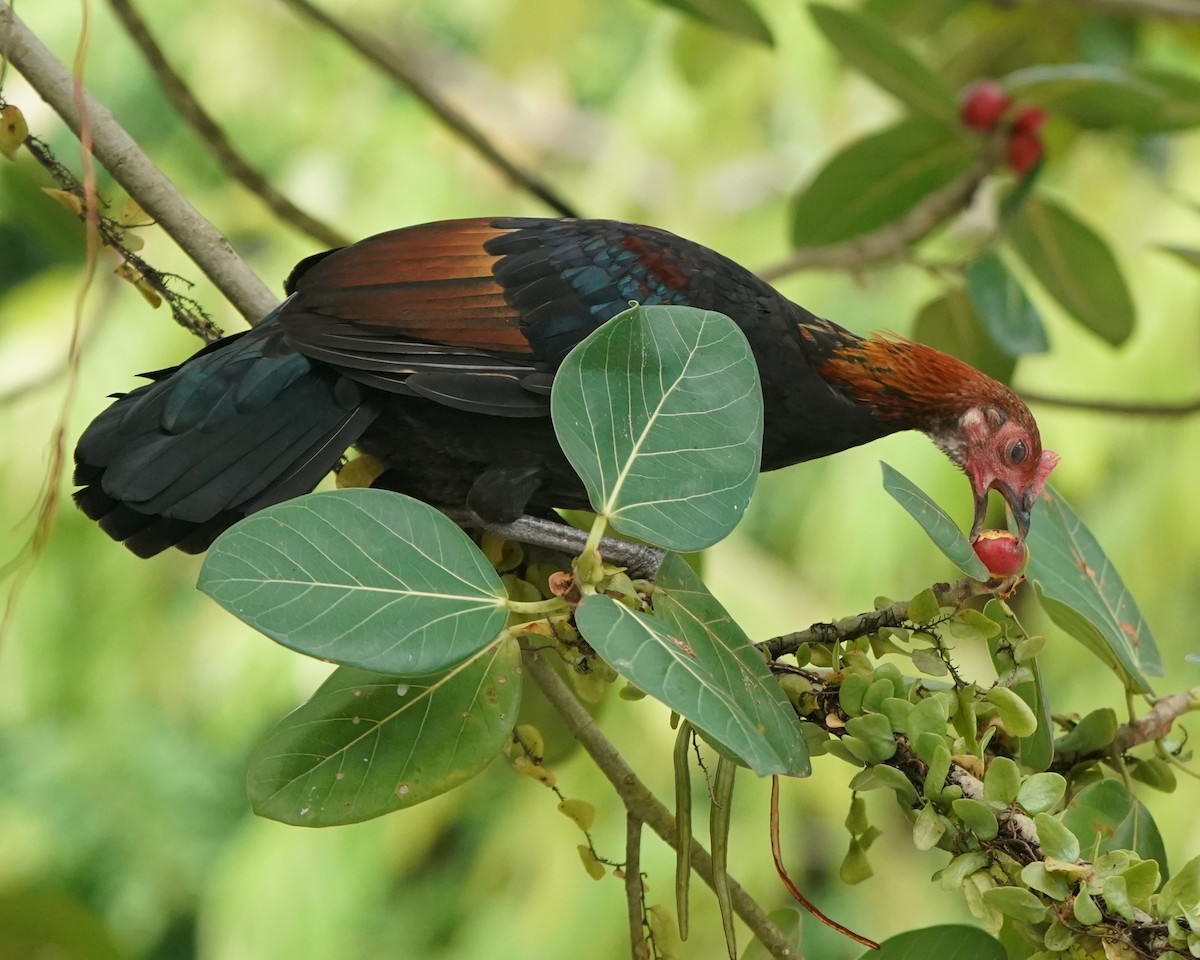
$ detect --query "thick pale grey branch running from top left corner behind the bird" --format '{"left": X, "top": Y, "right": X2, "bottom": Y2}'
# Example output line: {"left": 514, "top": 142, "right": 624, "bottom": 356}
{"left": 0, "top": 0, "right": 278, "bottom": 323}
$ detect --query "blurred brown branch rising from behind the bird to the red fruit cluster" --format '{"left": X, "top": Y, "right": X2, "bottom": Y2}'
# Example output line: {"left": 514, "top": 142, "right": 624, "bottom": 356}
{"left": 758, "top": 128, "right": 1008, "bottom": 280}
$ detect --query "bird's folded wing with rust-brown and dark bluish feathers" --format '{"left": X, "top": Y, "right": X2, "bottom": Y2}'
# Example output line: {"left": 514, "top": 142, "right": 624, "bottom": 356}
{"left": 272, "top": 218, "right": 692, "bottom": 416}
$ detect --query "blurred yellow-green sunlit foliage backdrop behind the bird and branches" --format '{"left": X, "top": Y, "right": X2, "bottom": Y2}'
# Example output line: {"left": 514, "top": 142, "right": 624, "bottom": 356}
{"left": 0, "top": 0, "right": 1200, "bottom": 960}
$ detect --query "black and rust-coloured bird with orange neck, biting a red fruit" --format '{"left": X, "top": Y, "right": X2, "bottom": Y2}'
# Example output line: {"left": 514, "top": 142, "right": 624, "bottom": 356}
{"left": 74, "top": 218, "right": 1057, "bottom": 557}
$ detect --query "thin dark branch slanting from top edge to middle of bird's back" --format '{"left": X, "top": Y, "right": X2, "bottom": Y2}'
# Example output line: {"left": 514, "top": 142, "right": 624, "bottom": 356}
{"left": 282, "top": 0, "right": 580, "bottom": 217}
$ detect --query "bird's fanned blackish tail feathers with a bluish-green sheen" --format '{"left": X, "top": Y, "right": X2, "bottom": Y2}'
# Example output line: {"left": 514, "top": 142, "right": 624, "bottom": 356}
{"left": 74, "top": 320, "right": 376, "bottom": 557}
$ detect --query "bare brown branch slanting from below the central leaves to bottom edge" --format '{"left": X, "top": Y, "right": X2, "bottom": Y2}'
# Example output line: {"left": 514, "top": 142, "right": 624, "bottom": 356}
{"left": 522, "top": 650, "right": 797, "bottom": 960}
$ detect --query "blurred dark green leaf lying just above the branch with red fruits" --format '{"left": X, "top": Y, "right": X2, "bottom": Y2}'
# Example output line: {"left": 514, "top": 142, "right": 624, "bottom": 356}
{"left": 792, "top": 116, "right": 974, "bottom": 247}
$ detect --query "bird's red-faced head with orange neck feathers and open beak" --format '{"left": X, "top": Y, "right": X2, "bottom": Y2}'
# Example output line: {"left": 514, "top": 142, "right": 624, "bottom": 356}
{"left": 820, "top": 336, "right": 1058, "bottom": 540}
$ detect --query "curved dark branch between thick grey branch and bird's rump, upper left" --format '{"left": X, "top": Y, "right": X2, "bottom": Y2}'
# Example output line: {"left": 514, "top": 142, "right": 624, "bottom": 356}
{"left": 108, "top": 0, "right": 350, "bottom": 247}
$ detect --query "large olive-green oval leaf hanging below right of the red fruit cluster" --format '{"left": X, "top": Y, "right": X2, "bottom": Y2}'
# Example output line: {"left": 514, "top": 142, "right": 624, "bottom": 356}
{"left": 1008, "top": 197, "right": 1134, "bottom": 347}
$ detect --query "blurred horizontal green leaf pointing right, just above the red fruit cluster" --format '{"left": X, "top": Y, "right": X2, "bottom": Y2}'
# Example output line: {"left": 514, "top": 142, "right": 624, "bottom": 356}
{"left": 1001, "top": 64, "right": 1166, "bottom": 131}
